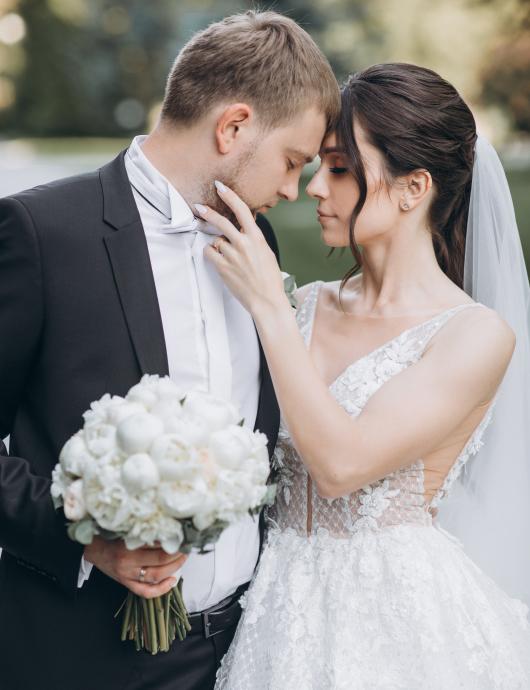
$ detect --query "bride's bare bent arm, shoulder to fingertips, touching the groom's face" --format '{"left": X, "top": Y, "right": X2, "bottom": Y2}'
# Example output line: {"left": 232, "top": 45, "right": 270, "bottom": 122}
{"left": 198, "top": 184, "right": 514, "bottom": 498}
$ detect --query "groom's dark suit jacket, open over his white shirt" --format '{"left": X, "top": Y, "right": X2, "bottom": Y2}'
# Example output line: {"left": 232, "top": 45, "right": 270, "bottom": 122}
{"left": 0, "top": 153, "right": 279, "bottom": 690}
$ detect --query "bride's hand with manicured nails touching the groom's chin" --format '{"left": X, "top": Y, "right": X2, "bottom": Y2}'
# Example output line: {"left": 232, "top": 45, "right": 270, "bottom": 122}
{"left": 196, "top": 183, "right": 288, "bottom": 315}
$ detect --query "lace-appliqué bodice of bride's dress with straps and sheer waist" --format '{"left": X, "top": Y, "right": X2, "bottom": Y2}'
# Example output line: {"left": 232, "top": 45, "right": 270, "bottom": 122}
{"left": 268, "top": 282, "right": 493, "bottom": 537}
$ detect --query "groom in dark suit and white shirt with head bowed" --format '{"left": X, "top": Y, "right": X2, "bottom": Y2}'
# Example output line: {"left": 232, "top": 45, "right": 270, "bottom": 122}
{"left": 0, "top": 12, "right": 339, "bottom": 690}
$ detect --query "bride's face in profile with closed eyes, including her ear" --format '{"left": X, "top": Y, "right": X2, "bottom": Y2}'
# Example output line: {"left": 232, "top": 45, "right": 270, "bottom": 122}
{"left": 306, "top": 125, "right": 402, "bottom": 247}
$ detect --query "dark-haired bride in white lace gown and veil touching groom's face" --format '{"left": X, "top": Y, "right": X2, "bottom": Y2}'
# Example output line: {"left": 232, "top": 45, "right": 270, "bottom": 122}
{"left": 198, "top": 64, "right": 530, "bottom": 690}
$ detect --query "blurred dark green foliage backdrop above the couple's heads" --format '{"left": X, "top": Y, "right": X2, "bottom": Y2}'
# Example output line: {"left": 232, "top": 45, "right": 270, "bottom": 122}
{"left": 0, "top": 0, "right": 530, "bottom": 140}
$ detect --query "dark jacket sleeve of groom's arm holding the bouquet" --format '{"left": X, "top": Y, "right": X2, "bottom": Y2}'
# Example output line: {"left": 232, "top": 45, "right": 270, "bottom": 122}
{"left": 0, "top": 198, "right": 83, "bottom": 589}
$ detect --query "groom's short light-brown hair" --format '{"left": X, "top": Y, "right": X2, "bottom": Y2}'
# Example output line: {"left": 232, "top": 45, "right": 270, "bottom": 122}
{"left": 162, "top": 10, "right": 340, "bottom": 130}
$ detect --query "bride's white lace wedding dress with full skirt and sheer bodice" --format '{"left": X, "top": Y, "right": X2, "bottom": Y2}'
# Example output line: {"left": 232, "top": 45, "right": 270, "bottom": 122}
{"left": 216, "top": 283, "right": 530, "bottom": 690}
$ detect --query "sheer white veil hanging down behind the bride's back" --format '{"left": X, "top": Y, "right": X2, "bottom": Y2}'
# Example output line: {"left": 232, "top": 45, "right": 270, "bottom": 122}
{"left": 439, "top": 136, "right": 530, "bottom": 605}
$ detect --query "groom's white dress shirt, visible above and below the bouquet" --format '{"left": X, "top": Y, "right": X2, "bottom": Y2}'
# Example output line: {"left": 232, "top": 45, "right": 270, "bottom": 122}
{"left": 78, "top": 136, "right": 260, "bottom": 613}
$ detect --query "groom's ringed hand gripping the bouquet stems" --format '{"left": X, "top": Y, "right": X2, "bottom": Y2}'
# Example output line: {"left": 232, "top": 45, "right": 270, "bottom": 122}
{"left": 84, "top": 537, "right": 188, "bottom": 599}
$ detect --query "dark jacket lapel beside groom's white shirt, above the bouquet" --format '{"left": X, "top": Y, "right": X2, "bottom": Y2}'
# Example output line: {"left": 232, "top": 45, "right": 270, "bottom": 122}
{"left": 100, "top": 152, "right": 169, "bottom": 376}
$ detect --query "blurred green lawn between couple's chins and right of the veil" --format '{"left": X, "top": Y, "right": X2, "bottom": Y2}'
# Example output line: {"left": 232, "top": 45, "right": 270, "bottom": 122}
{"left": 267, "top": 169, "right": 530, "bottom": 285}
